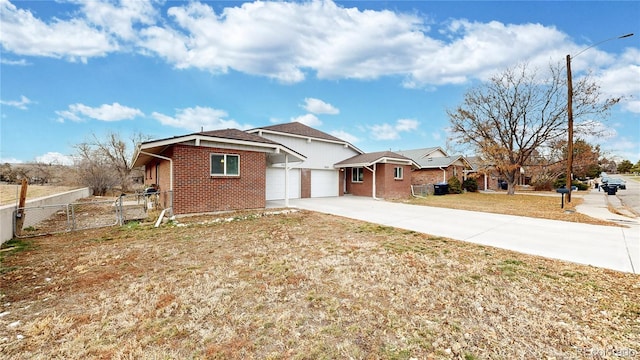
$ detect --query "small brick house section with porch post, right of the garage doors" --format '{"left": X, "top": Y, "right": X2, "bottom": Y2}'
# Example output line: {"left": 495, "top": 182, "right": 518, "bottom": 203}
{"left": 335, "top": 151, "right": 419, "bottom": 199}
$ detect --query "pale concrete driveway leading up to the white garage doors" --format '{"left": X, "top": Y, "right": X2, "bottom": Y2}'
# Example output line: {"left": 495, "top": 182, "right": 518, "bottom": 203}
{"left": 270, "top": 196, "right": 640, "bottom": 274}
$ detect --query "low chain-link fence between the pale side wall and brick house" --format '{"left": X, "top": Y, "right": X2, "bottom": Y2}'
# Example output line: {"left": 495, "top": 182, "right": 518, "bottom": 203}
{"left": 13, "top": 195, "right": 147, "bottom": 238}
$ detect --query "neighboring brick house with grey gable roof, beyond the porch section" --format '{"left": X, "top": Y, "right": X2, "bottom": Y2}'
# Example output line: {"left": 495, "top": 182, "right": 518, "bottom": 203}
{"left": 396, "top": 147, "right": 472, "bottom": 185}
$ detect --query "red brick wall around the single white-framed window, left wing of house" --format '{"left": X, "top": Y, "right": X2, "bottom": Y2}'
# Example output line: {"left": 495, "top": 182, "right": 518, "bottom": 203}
{"left": 168, "top": 145, "right": 266, "bottom": 214}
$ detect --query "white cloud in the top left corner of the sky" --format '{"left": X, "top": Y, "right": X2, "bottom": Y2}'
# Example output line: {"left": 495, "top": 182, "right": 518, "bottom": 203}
{"left": 0, "top": 0, "right": 118, "bottom": 62}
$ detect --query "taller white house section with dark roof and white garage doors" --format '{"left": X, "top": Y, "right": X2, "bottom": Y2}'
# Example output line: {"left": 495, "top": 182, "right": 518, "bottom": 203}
{"left": 247, "top": 122, "right": 362, "bottom": 200}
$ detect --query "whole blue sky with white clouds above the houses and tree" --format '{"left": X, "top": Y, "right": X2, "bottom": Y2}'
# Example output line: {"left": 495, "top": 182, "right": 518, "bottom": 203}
{"left": 0, "top": 0, "right": 640, "bottom": 163}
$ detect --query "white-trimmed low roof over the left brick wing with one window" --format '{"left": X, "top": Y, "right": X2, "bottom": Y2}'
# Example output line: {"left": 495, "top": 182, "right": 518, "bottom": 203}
{"left": 132, "top": 129, "right": 306, "bottom": 167}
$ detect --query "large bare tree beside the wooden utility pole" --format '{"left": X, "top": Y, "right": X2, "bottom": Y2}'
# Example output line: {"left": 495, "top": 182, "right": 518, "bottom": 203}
{"left": 447, "top": 64, "right": 619, "bottom": 194}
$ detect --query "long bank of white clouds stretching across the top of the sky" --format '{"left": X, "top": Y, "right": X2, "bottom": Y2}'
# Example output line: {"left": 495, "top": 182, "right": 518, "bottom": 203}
{"left": 0, "top": 0, "right": 640, "bottom": 91}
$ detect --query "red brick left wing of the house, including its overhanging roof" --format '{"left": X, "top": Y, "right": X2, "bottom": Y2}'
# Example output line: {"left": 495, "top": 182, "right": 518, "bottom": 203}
{"left": 133, "top": 129, "right": 306, "bottom": 214}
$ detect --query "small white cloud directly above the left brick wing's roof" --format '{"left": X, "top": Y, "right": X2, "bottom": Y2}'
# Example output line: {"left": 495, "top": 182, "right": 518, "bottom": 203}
{"left": 151, "top": 106, "right": 251, "bottom": 131}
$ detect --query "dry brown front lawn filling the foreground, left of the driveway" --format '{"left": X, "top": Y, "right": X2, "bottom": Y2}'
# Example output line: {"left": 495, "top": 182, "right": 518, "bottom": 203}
{"left": 0, "top": 211, "right": 640, "bottom": 359}
